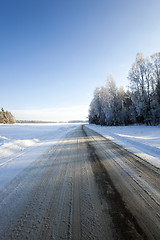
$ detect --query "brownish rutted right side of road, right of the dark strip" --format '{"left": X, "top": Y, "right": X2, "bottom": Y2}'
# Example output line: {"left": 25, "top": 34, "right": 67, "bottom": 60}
{"left": 85, "top": 124, "right": 160, "bottom": 240}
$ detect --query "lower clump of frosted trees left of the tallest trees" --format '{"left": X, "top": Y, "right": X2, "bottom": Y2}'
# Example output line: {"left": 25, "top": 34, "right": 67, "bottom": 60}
{"left": 89, "top": 75, "right": 130, "bottom": 126}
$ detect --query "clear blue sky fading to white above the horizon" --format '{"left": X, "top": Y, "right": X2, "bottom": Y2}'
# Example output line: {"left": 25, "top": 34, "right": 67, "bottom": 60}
{"left": 0, "top": 0, "right": 160, "bottom": 121}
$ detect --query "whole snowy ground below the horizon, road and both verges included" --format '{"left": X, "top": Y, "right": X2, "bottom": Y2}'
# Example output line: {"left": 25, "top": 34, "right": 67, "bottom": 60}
{"left": 0, "top": 124, "right": 160, "bottom": 240}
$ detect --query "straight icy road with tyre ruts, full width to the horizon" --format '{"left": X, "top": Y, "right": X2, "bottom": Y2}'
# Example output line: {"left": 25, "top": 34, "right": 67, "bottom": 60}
{"left": 0, "top": 126, "right": 160, "bottom": 240}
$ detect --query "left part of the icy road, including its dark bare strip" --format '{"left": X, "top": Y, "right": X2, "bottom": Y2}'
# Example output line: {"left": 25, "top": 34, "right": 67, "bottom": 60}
{"left": 0, "top": 124, "right": 158, "bottom": 240}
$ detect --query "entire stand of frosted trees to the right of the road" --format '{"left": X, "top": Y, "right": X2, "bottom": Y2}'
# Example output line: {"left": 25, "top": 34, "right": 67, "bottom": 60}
{"left": 89, "top": 53, "right": 160, "bottom": 126}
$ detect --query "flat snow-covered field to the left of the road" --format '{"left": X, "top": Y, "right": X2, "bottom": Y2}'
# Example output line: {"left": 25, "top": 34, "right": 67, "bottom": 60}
{"left": 0, "top": 124, "right": 77, "bottom": 190}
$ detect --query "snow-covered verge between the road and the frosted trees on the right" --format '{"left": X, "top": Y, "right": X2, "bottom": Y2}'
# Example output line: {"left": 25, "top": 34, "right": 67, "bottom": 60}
{"left": 86, "top": 124, "right": 160, "bottom": 168}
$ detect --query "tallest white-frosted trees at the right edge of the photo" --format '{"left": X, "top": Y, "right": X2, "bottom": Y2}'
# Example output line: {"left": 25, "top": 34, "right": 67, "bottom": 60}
{"left": 129, "top": 53, "right": 160, "bottom": 125}
